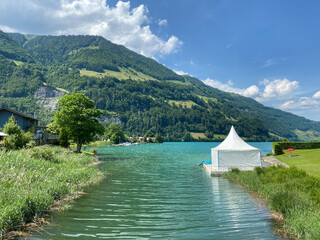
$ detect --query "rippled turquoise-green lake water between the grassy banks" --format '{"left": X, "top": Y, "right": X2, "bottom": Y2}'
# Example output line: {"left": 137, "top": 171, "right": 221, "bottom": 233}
{"left": 31, "top": 143, "right": 282, "bottom": 240}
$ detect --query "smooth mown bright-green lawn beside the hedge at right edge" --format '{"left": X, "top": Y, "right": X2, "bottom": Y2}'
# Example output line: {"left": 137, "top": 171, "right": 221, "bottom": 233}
{"left": 276, "top": 149, "right": 320, "bottom": 178}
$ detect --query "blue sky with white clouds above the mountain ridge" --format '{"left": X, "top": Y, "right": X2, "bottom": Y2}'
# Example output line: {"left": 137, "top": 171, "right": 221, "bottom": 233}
{"left": 0, "top": 0, "right": 320, "bottom": 121}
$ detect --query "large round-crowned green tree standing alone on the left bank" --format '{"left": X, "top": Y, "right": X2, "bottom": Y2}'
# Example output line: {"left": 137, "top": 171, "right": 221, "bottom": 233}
{"left": 54, "top": 93, "right": 104, "bottom": 153}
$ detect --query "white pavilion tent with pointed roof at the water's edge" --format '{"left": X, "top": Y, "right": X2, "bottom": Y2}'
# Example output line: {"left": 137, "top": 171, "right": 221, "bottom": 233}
{"left": 211, "top": 126, "right": 262, "bottom": 172}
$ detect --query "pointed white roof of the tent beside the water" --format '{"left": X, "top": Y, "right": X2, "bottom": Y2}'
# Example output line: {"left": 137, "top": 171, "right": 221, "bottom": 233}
{"left": 213, "top": 126, "right": 259, "bottom": 151}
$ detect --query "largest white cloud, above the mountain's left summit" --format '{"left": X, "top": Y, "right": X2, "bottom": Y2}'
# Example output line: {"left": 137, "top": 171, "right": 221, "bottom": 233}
{"left": 0, "top": 0, "right": 182, "bottom": 57}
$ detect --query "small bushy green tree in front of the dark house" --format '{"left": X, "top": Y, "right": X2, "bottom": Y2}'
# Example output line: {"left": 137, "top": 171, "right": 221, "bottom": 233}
{"left": 3, "top": 116, "right": 32, "bottom": 150}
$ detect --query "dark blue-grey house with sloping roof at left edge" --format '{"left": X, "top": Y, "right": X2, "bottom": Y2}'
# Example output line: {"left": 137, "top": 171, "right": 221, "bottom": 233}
{"left": 0, "top": 107, "right": 39, "bottom": 131}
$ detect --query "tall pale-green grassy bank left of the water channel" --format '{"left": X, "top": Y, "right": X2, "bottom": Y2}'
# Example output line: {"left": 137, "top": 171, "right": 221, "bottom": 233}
{"left": 0, "top": 146, "right": 103, "bottom": 239}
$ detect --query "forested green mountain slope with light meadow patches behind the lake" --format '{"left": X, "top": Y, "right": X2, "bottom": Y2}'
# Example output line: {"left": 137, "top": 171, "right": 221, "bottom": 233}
{"left": 0, "top": 32, "right": 320, "bottom": 141}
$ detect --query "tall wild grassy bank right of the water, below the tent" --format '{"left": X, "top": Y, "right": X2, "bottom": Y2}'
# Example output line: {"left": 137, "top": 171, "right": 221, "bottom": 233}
{"left": 224, "top": 167, "right": 320, "bottom": 239}
